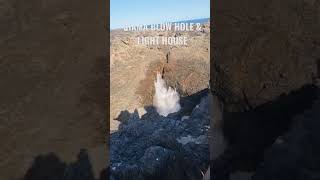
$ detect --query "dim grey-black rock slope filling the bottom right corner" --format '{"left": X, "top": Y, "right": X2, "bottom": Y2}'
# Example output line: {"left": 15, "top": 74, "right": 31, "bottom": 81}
{"left": 253, "top": 88, "right": 320, "bottom": 180}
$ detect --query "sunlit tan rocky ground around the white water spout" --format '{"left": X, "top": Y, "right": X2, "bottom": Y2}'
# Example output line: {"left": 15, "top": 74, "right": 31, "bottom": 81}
{"left": 110, "top": 23, "right": 210, "bottom": 132}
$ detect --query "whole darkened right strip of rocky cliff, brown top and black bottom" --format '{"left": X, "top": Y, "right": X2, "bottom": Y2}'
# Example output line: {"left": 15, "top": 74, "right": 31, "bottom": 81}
{"left": 211, "top": 0, "right": 320, "bottom": 180}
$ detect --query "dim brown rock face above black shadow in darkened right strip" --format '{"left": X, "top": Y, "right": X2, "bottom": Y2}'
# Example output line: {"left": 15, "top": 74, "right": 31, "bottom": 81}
{"left": 211, "top": 0, "right": 320, "bottom": 111}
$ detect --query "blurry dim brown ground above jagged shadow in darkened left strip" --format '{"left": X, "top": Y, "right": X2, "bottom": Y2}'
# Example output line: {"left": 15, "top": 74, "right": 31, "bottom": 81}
{"left": 0, "top": 0, "right": 108, "bottom": 180}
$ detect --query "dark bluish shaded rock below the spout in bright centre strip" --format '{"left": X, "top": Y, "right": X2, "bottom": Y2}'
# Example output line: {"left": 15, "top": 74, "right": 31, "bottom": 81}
{"left": 110, "top": 96, "right": 209, "bottom": 180}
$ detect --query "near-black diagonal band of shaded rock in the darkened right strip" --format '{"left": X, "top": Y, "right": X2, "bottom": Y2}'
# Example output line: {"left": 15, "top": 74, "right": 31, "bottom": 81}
{"left": 211, "top": 85, "right": 319, "bottom": 179}
